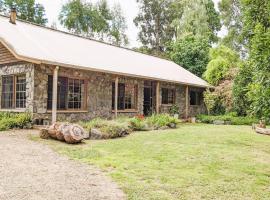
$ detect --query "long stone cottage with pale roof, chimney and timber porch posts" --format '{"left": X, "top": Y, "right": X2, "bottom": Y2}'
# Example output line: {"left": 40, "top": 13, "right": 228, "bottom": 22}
{"left": 0, "top": 11, "right": 209, "bottom": 123}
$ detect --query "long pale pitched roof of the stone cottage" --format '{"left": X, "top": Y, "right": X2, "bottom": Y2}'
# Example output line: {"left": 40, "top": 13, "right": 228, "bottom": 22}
{"left": 0, "top": 16, "right": 209, "bottom": 87}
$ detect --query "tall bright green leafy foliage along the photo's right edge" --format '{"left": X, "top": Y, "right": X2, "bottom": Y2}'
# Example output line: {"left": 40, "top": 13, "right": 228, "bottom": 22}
{"left": 248, "top": 23, "right": 270, "bottom": 120}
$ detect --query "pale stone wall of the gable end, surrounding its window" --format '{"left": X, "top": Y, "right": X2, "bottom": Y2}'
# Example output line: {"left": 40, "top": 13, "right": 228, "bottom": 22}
{"left": 0, "top": 63, "right": 34, "bottom": 112}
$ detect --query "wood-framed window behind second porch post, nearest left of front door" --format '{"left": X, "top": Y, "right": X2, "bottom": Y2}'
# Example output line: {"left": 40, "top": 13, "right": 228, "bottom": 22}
{"left": 112, "top": 83, "right": 138, "bottom": 110}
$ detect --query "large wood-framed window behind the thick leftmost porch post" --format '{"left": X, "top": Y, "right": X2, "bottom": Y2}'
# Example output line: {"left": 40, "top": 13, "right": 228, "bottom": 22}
{"left": 47, "top": 75, "right": 85, "bottom": 110}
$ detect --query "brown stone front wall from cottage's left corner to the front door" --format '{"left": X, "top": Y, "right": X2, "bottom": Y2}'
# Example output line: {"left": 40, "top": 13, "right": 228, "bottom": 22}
{"left": 34, "top": 65, "right": 146, "bottom": 121}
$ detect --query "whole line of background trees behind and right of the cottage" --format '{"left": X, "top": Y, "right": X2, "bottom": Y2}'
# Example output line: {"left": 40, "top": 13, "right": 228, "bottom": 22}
{"left": 0, "top": 0, "right": 270, "bottom": 119}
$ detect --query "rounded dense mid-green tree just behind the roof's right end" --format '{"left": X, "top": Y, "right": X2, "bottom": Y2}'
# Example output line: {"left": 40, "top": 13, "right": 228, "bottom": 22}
{"left": 169, "top": 35, "right": 210, "bottom": 77}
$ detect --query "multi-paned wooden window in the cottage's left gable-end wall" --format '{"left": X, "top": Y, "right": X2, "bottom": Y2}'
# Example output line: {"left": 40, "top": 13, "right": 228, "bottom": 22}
{"left": 1, "top": 75, "right": 26, "bottom": 109}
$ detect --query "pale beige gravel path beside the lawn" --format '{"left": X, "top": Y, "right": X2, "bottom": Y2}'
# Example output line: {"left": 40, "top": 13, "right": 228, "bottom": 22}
{"left": 0, "top": 131, "right": 125, "bottom": 200}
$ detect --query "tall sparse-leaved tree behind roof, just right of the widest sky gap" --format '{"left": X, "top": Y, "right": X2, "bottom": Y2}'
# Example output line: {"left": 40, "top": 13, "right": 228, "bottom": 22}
{"left": 134, "top": 0, "right": 174, "bottom": 54}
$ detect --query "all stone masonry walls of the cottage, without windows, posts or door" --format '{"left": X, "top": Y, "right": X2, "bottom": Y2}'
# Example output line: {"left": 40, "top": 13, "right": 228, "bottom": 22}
{"left": 0, "top": 63, "right": 206, "bottom": 121}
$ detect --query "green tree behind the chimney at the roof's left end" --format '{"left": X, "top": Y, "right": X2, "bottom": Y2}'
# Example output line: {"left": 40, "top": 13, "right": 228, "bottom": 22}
{"left": 0, "top": 0, "right": 48, "bottom": 25}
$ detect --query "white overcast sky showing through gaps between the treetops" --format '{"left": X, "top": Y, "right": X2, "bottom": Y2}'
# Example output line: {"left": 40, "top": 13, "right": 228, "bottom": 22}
{"left": 36, "top": 0, "right": 226, "bottom": 47}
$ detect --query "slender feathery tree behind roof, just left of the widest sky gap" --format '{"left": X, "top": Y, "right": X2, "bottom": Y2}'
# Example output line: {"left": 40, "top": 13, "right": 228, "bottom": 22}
{"left": 110, "top": 4, "right": 128, "bottom": 46}
